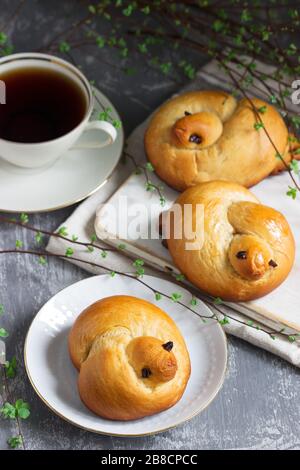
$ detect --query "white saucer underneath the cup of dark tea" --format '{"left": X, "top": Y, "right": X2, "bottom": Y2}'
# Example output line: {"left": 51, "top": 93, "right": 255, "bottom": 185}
{"left": 0, "top": 89, "right": 124, "bottom": 212}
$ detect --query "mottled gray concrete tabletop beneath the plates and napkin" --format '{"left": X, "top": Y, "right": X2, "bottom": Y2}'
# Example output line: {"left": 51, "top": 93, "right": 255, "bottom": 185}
{"left": 0, "top": 0, "right": 300, "bottom": 450}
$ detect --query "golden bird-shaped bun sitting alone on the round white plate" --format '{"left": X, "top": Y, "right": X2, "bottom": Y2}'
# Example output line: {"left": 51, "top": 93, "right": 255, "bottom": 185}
{"left": 69, "top": 295, "right": 190, "bottom": 420}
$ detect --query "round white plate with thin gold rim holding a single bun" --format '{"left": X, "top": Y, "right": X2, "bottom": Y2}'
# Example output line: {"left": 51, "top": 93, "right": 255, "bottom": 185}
{"left": 24, "top": 275, "right": 227, "bottom": 436}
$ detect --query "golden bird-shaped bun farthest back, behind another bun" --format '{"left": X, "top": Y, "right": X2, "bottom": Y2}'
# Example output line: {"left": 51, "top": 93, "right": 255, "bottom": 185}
{"left": 145, "top": 91, "right": 288, "bottom": 191}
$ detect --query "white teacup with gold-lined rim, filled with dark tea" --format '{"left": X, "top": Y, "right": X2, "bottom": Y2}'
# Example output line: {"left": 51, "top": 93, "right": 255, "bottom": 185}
{"left": 0, "top": 53, "right": 117, "bottom": 168}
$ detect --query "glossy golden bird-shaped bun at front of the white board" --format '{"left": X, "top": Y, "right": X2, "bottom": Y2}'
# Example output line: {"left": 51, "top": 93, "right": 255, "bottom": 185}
{"left": 168, "top": 181, "right": 295, "bottom": 301}
